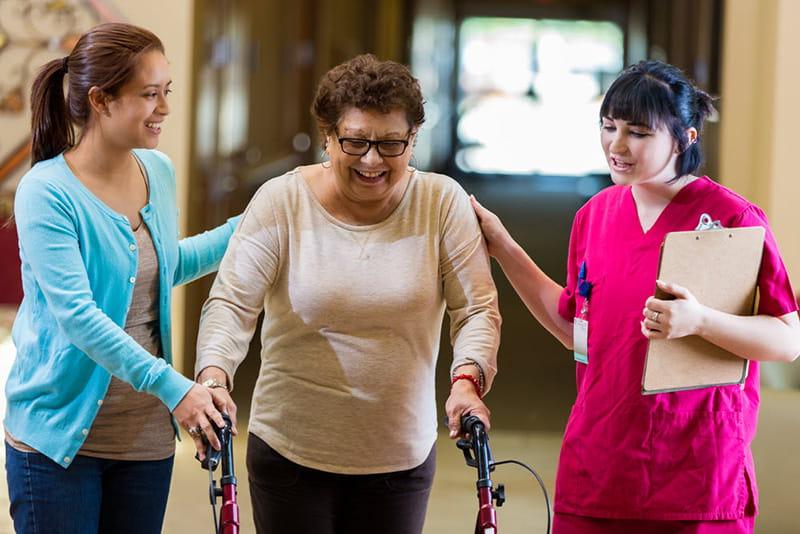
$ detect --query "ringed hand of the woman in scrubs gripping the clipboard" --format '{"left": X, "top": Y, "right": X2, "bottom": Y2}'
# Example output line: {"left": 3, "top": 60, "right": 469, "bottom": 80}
{"left": 641, "top": 280, "right": 706, "bottom": 339}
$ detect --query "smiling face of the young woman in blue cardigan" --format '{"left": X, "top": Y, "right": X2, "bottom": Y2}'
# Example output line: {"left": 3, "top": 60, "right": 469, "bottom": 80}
{"left": 98, "top": 51, "right": 172, "bottom": 149}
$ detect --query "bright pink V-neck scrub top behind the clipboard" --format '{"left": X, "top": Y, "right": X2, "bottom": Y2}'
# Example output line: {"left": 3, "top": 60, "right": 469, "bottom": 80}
{"left": 555, "top": 177, "right": 797, "bottom": 520}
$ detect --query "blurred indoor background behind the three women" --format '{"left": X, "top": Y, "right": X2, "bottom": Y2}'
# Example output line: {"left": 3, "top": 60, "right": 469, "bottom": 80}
{"left": 0, "top": 0, "right": 800, "bottom": 533}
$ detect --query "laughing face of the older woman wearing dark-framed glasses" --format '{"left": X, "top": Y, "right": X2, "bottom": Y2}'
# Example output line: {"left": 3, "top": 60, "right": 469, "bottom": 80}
{"left": 326, "top": 108, "right": 415, "bottom": 209}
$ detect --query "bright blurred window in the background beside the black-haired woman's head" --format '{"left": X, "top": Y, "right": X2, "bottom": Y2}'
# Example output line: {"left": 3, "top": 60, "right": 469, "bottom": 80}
{"left": 455, "top": 17, "right": 624, "bottom": 176}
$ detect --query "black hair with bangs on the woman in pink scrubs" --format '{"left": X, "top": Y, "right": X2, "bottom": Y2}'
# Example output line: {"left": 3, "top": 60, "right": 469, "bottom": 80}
{"left": 600, "top": 60, "right": 714, "bottom": 180}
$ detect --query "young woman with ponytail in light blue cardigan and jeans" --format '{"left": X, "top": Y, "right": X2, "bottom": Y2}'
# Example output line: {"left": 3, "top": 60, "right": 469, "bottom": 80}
{"left": 4, "top": 23, "right": 241, "bottom": 534}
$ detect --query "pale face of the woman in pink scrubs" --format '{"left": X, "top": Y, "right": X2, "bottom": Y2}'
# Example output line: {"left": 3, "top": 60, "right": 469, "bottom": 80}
{"left": 600, "top": 117, "right": 679, "bottom": 185}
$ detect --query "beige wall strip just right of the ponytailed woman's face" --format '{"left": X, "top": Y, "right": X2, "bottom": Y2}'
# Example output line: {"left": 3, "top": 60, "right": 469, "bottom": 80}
{"left": 116, "top": 0, "right": 194, "bottom": 371}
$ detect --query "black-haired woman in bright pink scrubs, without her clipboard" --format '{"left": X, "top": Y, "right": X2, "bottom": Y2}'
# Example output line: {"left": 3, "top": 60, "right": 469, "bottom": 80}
{"left": 473, "top": 61, "right": 800, "bottom": 534}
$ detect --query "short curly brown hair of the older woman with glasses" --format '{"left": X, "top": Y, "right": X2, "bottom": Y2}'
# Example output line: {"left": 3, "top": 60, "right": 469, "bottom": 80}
{"left": 311, "top": 54, "right": 425, "bottom": 143}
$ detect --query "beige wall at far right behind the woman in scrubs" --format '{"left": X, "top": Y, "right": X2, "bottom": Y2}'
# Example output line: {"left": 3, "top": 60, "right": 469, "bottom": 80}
{"left": 720, "top": 0, "right": 800, "bottom": 387}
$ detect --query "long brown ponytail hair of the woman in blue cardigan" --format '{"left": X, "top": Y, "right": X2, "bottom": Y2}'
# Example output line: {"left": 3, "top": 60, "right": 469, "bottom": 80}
{"left": 31, "top": 22, "right": 164, "bottom": 164}
